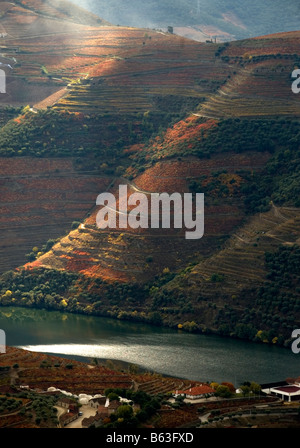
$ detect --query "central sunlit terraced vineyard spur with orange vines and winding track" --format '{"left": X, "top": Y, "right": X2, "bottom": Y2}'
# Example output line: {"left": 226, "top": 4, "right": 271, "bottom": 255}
{"left": 27, "top": 153, "right": 270, "bottom": 283}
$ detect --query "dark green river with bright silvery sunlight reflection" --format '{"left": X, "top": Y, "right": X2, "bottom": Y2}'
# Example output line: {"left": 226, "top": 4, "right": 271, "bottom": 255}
{"left": 0, "top": 307, "right": 300, "bottom": 385}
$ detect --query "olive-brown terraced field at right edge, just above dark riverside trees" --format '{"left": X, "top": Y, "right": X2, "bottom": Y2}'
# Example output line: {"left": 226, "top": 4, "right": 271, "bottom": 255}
{"left": 184, "top": 205, "right": 300, "bottom": 297}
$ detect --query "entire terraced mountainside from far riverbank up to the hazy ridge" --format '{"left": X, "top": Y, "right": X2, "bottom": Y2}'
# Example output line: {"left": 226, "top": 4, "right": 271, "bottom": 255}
{"left": 0, "top": 0, "right": 300, "bottom": 352}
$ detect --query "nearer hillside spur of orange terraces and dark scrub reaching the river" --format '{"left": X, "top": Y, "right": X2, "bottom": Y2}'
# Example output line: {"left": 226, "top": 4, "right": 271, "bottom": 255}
{"left": 5, "top": 114, "right": 300, "bottom": 344}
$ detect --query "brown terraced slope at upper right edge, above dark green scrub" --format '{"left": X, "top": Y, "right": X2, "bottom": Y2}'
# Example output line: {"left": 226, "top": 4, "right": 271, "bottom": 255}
{"left": 199, "top": 32, "right": 300, "bottom": 118}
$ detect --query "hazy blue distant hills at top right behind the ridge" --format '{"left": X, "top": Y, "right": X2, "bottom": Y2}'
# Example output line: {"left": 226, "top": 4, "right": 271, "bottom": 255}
{"left": 69, "top": 0, "right": 300, "bottom": 41}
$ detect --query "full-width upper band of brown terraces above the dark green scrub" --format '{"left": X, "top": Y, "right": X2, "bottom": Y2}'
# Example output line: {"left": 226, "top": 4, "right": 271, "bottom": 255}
{"left": 0, "top": 1, "right": 300, "bottom": 118}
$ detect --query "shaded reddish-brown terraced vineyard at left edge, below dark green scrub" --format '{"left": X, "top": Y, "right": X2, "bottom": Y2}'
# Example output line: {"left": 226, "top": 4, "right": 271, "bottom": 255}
{"left": 0, "top": 158, "right": 111, "bottom": 272}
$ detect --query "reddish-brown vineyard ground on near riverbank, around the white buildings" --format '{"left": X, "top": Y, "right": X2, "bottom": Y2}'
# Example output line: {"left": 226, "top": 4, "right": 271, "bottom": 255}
{"left": 0, "top": 347, "right": 286, "bottom": 428}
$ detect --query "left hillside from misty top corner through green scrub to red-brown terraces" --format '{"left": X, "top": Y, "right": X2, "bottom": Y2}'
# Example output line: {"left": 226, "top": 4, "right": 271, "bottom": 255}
{"left": 0, "top": 1, "right": 232, "bottom": 271}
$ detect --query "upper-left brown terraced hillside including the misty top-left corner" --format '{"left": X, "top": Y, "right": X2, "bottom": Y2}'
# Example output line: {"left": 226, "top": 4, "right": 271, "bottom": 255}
{"left": 0, "top": 1, "right": 231, "bottom": 110}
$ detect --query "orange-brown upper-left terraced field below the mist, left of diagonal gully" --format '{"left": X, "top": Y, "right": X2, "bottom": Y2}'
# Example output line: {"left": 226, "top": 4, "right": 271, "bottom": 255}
{"left": 4, "top": 23, "right": 231, "bottom": 113}
